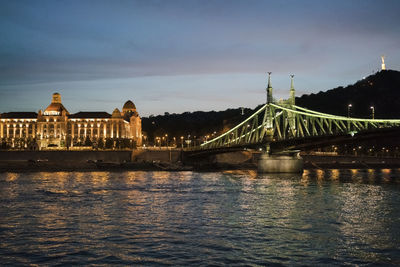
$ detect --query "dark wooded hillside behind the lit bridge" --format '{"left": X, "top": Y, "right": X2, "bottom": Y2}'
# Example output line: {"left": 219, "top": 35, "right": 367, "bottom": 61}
{"left": 142, "top": 70, "right": 400, "bottom": 144}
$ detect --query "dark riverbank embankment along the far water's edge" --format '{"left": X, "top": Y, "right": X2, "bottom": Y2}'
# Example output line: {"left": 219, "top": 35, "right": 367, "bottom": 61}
{"left": 0, "top": 149, "right": 400, "bottom": 172}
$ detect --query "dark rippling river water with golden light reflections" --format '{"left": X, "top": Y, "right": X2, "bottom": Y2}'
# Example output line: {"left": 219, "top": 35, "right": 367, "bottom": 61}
{"left": 0, "top": 170, "right": 400, "bottom": 266}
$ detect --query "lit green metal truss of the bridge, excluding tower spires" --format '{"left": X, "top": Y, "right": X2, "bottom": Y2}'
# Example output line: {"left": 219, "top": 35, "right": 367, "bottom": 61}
{"left": 202, "top": 103, "right": 400, "bottom": 150}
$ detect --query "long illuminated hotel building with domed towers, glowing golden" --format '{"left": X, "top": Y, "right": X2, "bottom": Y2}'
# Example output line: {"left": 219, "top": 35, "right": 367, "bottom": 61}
{"left": 0, "top": 93, "right": 142, "bottom": 150}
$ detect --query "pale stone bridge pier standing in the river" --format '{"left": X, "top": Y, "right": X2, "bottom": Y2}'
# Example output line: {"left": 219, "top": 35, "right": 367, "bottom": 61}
{"left": 258, "top": 152, "right": 303, "bottom": 173}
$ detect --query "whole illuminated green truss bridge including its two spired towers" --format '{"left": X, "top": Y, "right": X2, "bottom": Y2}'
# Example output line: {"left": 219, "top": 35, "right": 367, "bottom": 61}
{"left": 192, "top": 73, "right": 400, "bottom": 153}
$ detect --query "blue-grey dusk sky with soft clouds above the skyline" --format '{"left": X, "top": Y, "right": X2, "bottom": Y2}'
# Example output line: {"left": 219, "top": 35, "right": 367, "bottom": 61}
{"left": 0, "top": 0, "right": 400, "bottom": 116}
